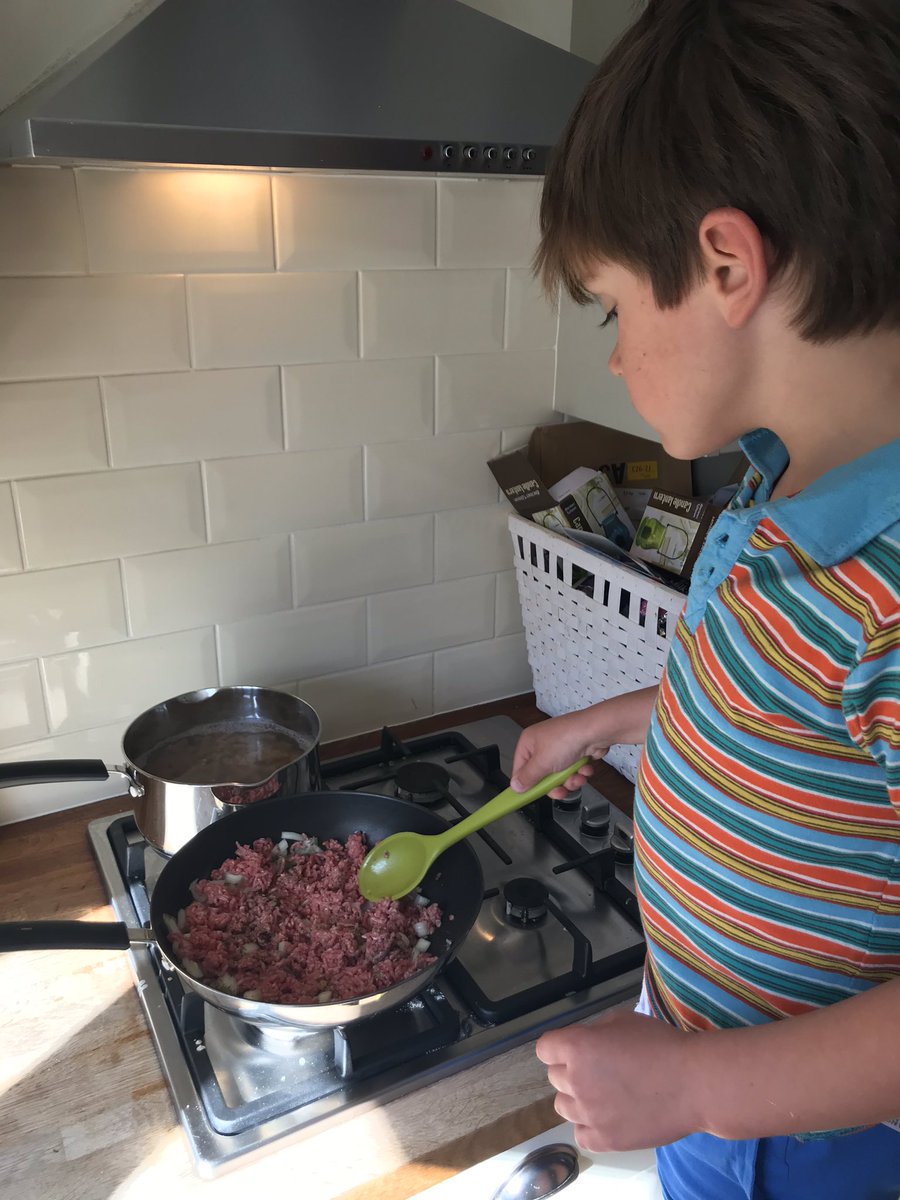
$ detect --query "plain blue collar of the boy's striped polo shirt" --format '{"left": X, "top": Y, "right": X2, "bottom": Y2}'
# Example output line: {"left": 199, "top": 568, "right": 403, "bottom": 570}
{"left": 740, "top": 430, "right": 900, "bottom": 566}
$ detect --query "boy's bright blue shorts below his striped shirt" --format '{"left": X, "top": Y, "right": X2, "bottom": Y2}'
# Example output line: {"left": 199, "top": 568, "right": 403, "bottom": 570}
{"left": 656, "top": 1124, "right": 900, "bottom": 1200}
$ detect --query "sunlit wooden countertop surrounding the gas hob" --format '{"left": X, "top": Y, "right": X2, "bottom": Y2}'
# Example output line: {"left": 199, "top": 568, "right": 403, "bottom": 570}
{"left": 0, "top": 696, "right": 631, "bottom": 1200}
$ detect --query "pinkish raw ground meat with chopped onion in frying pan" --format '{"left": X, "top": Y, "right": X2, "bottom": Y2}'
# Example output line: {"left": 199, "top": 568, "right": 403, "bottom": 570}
{"left": 167, "top": 833, "right": 442, "bottom": 1004}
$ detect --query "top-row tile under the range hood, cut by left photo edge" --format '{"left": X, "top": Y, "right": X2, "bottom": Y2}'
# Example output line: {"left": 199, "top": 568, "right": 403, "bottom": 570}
{"left": 0, "top": 167, "right": 86, "bottom": 275}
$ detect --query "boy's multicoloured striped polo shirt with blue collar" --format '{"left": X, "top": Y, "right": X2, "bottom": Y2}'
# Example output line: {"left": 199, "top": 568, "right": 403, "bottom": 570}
{"left": 635, "top": 430, "right": 900, "bottom": 1030}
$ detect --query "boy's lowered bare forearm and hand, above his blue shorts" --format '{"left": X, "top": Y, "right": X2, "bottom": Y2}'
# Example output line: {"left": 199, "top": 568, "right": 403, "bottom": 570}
{"left": 538, "top": 960, "right": 900, "bottom": 1151}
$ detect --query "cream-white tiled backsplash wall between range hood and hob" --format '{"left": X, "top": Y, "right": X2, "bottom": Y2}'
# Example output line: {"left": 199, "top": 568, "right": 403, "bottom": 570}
{"left": 0, "top": 167, "right": 557, "bottom": 822}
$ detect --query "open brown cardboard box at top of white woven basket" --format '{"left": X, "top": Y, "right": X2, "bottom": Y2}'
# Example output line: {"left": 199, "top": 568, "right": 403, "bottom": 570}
{"left": 488, "top": 421, "right": 691, "bottom": 532}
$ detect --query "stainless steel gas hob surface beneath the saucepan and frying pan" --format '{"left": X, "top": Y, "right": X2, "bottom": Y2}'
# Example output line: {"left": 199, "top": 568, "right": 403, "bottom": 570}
{"left": 89, "top": 716, "right": 643, "bottom": 1176}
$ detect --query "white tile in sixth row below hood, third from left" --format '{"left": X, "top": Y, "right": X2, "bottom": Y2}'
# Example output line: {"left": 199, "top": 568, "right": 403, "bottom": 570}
{"left": 218, "top": 600, "right": 366, "bottom": 686}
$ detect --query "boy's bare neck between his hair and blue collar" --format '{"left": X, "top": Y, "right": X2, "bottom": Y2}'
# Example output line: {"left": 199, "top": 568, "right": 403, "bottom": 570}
{"left": 760, "top": 321, "right": 900, "bottom": 499}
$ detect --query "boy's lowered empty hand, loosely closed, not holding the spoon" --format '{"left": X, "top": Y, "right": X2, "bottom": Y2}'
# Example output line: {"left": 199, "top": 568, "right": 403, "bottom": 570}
{"left": 536, "top": 1013, "right": 697, "bottom": 1151}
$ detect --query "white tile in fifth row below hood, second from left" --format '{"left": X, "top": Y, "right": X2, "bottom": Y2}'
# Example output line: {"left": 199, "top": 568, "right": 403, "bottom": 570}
{"left": 124, "top": 538, "right": 292, "bottom": 637}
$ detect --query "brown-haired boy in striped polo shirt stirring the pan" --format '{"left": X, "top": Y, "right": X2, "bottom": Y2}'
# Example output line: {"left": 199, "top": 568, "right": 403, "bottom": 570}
{"left": 514, "top": 0, "right": 900, "bottom": 1200}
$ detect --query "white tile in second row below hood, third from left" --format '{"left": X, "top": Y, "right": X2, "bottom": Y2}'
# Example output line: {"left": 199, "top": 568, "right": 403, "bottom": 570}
{"left": 362, "top": 270, "right": 505, "bottom": 359}
